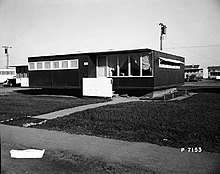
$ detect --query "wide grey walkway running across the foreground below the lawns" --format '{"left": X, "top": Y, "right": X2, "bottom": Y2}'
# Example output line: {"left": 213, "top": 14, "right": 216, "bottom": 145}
{"left": 1, "top": 125, "right": 220, "bottom": 174}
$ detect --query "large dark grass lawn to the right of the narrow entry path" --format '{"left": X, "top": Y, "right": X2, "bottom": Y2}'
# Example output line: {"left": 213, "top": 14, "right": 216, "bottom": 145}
{"left": 36, "top": 93, "right": 220, "bottom": 152}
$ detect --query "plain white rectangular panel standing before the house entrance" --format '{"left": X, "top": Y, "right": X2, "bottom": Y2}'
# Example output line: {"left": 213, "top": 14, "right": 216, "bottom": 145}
{"left": 83, "top": 77, "right": 113, "bottom": 97}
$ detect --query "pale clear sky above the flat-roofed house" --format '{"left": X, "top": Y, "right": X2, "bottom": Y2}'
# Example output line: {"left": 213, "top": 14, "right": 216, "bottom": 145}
{"left": 0, "top": 0, "right": 220, "bottom": 72}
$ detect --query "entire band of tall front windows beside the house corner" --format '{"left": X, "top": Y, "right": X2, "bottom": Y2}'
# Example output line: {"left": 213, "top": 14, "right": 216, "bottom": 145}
{"left": 96, "top": 52, "right": 153, "bottom": 77}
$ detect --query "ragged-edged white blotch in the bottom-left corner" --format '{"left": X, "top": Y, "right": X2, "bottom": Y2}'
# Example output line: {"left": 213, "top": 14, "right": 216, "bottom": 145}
{"left": 10, "top": 149, "right": 45, "bottom": 158}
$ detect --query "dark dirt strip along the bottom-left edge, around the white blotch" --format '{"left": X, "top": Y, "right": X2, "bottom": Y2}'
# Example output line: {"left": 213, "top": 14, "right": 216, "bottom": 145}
{"left": 1, "top": 142, "right": 154, "bottom": 174}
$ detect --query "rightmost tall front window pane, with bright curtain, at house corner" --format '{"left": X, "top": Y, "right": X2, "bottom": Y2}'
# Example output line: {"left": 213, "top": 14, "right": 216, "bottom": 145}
{"left": 142, "top": 53, "right": 152, "bottom": 76}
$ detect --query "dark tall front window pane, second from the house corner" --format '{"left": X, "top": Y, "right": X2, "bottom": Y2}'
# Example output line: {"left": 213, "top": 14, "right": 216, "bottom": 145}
{"left": 130, "top": 53, "right": 140, "bottom": 76}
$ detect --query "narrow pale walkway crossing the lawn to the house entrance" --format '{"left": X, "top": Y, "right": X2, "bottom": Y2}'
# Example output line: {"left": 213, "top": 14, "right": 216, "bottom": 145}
{"left": 32, "top": 97, "right": 141, "bottom": 120}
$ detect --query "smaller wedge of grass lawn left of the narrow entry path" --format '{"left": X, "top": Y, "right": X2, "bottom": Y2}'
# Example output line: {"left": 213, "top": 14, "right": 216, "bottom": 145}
{"left": 0, "top": 92, "right": 108, "bottom": 121}
